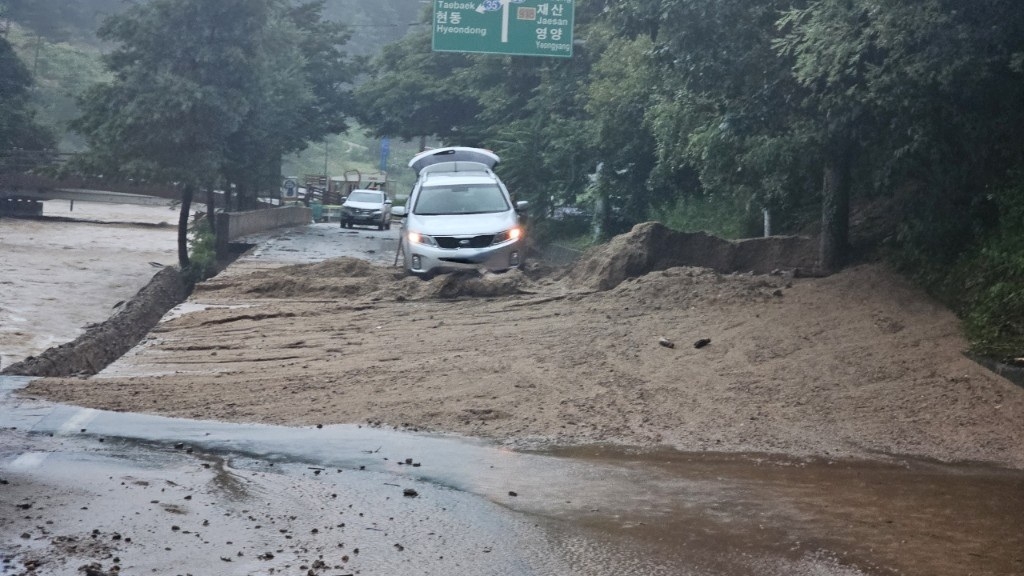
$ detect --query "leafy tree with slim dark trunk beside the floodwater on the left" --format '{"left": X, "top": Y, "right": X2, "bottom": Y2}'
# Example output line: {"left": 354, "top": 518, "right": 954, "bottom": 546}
{"left": 75, "top": 0, "right": 270, "bottom": 270}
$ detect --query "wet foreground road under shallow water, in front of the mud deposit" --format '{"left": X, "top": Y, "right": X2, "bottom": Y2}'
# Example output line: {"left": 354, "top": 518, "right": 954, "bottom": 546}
{"left": 0, "top": 381, "right": 1024, "bottom": 576}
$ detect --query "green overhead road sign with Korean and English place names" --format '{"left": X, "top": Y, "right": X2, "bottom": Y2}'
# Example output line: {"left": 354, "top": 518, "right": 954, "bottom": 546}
{"left": 433, "top": 0, "right": 574, "bottom": 58}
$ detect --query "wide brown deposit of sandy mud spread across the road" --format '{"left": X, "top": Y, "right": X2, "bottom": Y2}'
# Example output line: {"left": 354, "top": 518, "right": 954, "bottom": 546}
{"left": 22, "top": 219, "right": 1024, "bottom": 467}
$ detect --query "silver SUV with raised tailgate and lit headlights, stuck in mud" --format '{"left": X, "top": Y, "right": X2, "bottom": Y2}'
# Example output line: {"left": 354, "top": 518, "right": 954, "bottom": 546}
{"left": 393, "top": 148, "right": 526, "bottom": 275}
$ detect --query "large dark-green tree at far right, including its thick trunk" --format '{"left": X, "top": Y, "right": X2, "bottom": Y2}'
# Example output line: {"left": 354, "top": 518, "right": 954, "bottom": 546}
{"left": 776, "top": 0, "right": 1024, "bottom": 269}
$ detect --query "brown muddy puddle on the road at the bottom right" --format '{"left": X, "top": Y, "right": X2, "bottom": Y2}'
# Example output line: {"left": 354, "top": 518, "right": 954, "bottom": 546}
{"left": 540, "top": 448, "right": 1024, "bottom": 575}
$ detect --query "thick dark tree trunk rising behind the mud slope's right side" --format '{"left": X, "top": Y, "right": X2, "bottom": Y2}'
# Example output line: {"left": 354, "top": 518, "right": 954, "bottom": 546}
{"left": 819, "top": 147, "right": 851, "bottom": 274}
